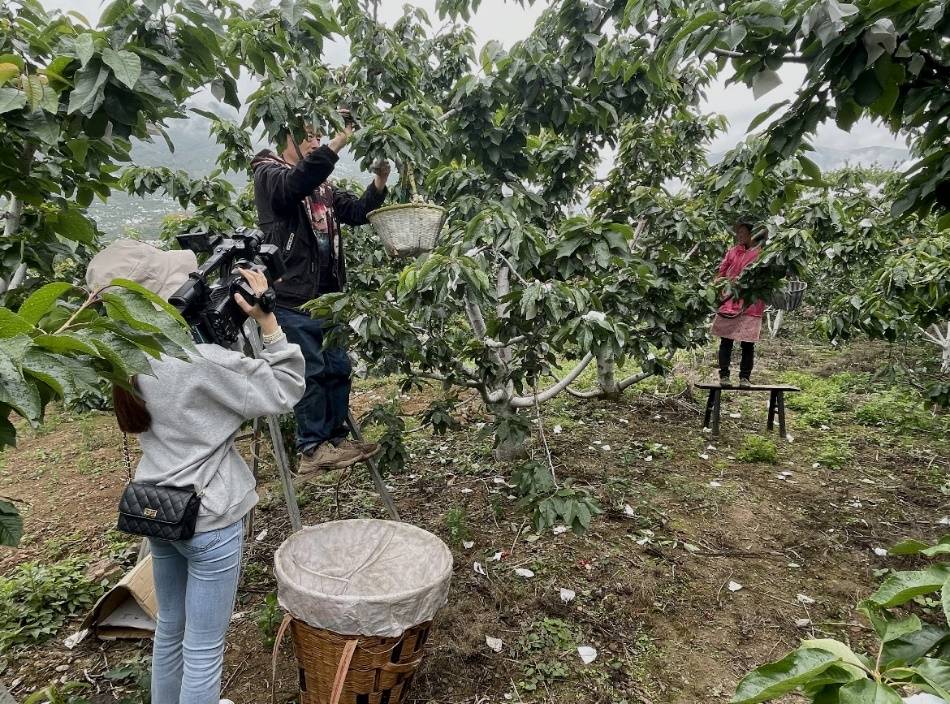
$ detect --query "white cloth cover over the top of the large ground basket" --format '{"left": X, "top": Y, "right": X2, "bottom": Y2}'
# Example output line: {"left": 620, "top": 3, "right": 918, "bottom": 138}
{"left": 274, "top": 519, "right": 452, "bottom": 638}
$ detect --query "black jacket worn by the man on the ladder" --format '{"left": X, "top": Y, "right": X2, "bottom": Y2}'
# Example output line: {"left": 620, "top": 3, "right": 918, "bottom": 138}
{"left": 251, "top": 146, "right": 386, "bottom": 308}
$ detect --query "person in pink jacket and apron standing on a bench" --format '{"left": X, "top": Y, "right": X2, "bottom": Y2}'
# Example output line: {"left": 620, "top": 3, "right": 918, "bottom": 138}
{"left": 712, "top": 219, "right": 765, "bottom": 386}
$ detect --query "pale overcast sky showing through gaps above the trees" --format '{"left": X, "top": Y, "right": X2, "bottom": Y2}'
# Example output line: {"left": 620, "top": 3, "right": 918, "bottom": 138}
{"left": 41, "top": 0, "right": 904, "bottom": 152}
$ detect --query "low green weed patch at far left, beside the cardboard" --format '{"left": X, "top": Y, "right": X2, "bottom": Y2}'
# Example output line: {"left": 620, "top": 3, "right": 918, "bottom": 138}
{"left": 0, "top": 558, "right": 105, "bottom": 653}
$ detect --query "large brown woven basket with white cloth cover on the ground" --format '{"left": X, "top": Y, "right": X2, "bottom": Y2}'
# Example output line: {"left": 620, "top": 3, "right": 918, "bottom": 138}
{"left": 273, "top": 519, "right": 452, "bottom": 704}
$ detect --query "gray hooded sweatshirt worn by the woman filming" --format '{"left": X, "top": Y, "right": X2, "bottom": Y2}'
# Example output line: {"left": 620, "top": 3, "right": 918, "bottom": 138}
{"left": 135, "top": 339, "right": 305, "bottom": 533}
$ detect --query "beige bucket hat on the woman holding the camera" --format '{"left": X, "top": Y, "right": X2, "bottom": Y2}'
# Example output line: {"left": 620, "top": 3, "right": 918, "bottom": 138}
{"left": 86, "top": 240, "right": 198, "bottom": 299}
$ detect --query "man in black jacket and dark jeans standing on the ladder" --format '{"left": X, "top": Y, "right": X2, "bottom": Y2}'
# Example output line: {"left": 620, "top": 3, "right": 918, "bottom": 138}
{"left": 251, "top": 114, "right": 390, "bottom": 474}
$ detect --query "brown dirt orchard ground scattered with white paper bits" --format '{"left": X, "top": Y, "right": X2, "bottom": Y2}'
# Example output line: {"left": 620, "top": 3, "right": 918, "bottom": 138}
{"left": 0, "top": 332, "right": 950, "bottom": 704}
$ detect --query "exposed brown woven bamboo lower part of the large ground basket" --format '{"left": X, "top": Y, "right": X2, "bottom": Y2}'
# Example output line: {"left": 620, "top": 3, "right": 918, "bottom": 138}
{"left": 291, "top": 619, "right": 431, "bottom": 704}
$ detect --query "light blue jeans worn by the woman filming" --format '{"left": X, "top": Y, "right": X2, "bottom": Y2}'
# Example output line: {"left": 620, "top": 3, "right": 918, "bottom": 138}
{"left": 149, "top": 521, "right": 244, "bottom": 704}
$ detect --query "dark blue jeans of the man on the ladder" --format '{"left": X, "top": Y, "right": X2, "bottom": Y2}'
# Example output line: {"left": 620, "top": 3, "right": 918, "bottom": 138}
{"left": 276, "top": 308, "right": 353, "bottom": 453}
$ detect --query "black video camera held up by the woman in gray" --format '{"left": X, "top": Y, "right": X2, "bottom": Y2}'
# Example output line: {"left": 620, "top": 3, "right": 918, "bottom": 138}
{"left": 168, "top": 228, "right": 285, "bottom": 347}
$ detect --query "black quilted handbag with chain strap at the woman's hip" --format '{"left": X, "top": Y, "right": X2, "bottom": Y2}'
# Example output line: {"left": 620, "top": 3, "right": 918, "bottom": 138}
{"left": 116, "top": 438, "right": 201, "bottom": 540}
